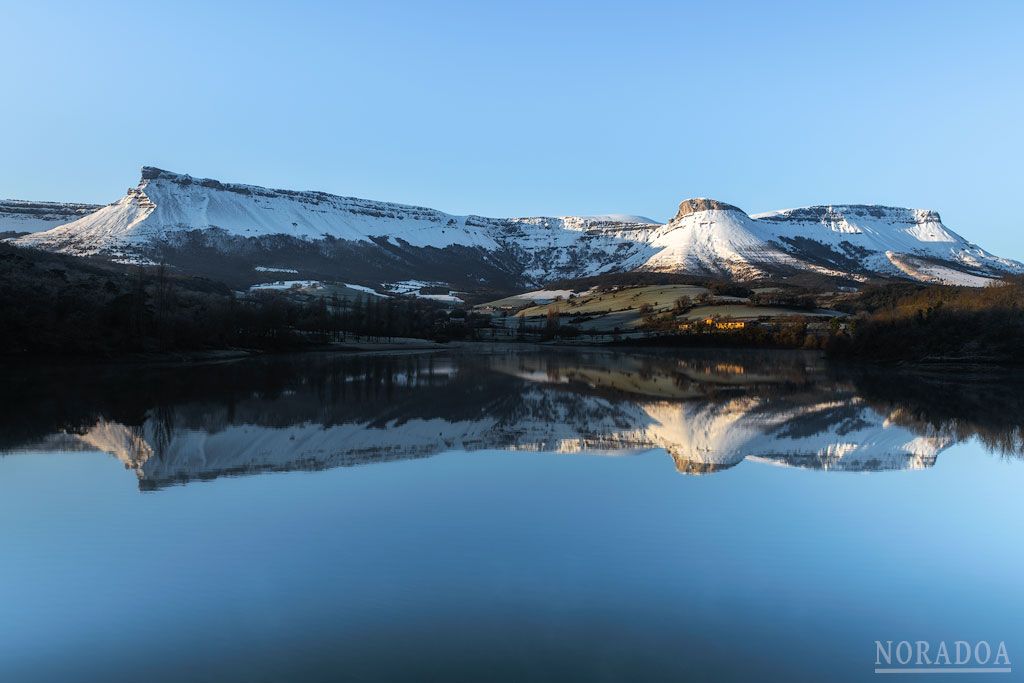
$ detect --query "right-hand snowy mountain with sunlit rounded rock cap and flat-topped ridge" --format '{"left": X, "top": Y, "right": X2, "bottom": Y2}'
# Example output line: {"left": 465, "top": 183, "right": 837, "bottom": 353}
{"left": 645, "top": 199, "right": 1024, "bottom": 285}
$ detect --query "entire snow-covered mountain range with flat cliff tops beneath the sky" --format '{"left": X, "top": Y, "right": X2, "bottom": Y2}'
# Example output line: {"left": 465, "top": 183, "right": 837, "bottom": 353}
{"left": 17, "top": 167, "right": 1024, "bottom": 289}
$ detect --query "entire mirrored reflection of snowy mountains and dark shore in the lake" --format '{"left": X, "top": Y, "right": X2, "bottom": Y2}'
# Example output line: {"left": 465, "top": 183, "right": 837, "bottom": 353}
{"left": 0, "top": 349, "right": 1024, "bottom": 489}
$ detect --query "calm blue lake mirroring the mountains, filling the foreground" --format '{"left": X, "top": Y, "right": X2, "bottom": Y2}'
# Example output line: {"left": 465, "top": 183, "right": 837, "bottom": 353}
{"left": 0, "top": 348, "right": 1024, "bottom": 682}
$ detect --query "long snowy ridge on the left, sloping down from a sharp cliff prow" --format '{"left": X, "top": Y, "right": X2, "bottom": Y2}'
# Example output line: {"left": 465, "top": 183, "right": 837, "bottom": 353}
{"left": 18, "top": 167, "right": 652, "bottom": 288}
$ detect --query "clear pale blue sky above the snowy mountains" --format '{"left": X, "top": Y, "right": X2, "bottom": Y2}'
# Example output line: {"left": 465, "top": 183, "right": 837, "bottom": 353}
{"left": 6, "top": 0, "right": 1024, "bottom": 258}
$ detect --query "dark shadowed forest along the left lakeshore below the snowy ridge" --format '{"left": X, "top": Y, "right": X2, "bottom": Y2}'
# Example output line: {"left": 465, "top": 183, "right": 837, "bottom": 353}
{"left": 0, "top": 244, "right": 483, "bottom": 355}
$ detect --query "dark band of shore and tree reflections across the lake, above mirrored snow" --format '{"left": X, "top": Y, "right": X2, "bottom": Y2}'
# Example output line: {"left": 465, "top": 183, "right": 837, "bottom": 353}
{"left": 0, "top": 349, "right": 1024, "bottom": 456}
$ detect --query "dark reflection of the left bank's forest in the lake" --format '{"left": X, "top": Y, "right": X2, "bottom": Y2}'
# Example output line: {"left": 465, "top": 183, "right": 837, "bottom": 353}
{"left": 0, "top": 353, "right": 518, "bottom": 450}
